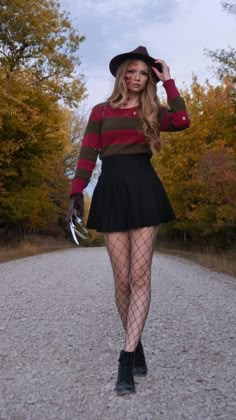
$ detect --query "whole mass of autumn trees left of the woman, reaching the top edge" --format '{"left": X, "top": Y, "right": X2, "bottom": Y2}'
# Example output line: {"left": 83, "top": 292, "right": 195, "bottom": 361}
{"left": 0, "top": 0, "right": 85, "bottom": 238}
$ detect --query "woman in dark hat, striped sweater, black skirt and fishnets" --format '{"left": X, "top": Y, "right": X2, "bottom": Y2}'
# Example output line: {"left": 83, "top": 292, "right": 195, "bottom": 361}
{"left": 68, "top": 47, "right": 189, "bottom": 395}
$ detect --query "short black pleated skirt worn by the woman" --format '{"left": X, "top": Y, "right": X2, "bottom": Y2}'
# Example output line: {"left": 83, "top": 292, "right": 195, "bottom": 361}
{"left": 87, "top": 154, "right": 175, "bottom": 232}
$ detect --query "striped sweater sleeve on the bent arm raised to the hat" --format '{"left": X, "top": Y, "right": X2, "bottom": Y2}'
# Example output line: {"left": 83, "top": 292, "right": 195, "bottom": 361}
{"left": 158, "top": 79, "right": 190, "bottom": 131}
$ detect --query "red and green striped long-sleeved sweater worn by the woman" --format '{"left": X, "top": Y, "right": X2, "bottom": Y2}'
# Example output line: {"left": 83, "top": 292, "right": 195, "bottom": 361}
{"left": 70, "top": 79, "right": 190, "bottom": 195}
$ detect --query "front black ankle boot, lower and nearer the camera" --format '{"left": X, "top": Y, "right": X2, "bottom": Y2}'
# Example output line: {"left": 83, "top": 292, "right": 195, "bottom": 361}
{"left": 115, "top": 350, "right": 135, "bottom": 395}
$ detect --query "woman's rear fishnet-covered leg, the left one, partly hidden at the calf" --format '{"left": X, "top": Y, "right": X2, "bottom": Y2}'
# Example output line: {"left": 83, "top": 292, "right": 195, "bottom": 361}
{"left": 104, "top": 232, "right": 131, "bottom": 330}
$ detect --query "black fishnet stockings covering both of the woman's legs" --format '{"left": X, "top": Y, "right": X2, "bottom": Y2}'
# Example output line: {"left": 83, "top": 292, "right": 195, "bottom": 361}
{"left": 105, "top": 226, "right": 157, "bottom": 351}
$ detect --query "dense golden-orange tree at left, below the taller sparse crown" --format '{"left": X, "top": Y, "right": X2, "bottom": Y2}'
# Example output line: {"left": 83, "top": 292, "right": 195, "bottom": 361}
{"left": 0, "top": 72, "right": 68, "bottom": 228}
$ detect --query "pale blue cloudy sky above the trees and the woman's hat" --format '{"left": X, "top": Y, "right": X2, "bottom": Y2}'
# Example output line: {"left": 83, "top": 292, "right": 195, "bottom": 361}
{"left": 61, "top": 0, "right": 236, "bottom": 109}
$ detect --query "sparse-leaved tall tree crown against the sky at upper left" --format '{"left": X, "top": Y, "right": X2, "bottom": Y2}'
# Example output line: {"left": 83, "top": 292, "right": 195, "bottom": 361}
{"left": 0, "top": 0, "right": 85, "bottom": 106}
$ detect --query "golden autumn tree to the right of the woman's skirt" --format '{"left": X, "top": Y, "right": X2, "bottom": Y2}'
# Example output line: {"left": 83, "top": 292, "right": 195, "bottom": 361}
{"left": 154, "top": 78, "right": 236, "bottom": 244}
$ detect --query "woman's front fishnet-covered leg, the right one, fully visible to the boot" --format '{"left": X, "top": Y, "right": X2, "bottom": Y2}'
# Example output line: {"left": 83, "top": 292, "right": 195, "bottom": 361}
{"left": 125, "top": 226, "right": 158, "bottom": 352}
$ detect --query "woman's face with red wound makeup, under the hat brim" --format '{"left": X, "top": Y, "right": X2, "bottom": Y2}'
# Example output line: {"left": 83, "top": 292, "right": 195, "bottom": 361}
{"left": 125, "top": 60, "right": 148, "bottom": 93}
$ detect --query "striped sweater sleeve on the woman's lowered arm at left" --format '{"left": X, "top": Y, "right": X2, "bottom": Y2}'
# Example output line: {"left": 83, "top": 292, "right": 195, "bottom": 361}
{"left": 70, "top": 105, "right": 102, "bottom": 196}
